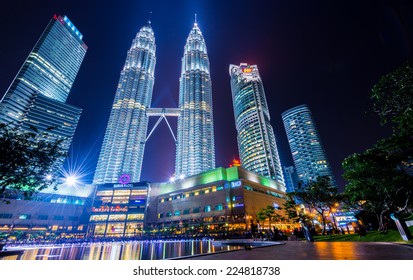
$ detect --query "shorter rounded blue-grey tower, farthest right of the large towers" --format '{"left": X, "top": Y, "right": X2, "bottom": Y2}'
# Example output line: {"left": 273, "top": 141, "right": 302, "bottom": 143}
{"left": 281, "top": 105, "right": 336, "bottom": 185}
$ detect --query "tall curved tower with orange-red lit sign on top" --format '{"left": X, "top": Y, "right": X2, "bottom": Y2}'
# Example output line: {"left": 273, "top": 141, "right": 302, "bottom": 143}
{"left": 229, "top": 63, "right": 284, "bottom": 183}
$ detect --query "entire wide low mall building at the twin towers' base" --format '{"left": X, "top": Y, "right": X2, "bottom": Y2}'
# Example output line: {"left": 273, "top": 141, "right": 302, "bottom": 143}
{"left": 0, "top": 166, "right": 289, "bottom": 237}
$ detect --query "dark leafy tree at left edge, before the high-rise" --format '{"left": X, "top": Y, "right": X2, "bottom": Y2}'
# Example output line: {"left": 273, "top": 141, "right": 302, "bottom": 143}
{"left": 0, "top": 124, "right": 66, "bottom": 201}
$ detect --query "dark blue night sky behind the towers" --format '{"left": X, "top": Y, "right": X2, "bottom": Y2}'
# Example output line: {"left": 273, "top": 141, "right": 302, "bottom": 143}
{"left": 0, "top": 0, "right": 413, "bottom": 187}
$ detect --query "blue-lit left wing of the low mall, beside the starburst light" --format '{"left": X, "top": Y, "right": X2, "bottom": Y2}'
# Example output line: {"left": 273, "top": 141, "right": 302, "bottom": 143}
{"left": 0, "top": 184, "right": 95, "bottom": 239}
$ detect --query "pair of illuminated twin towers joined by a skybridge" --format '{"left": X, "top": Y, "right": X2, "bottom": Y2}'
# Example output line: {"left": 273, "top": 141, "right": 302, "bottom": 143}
{"left": 93, "top": 22, "right": 215, "bottom": 184}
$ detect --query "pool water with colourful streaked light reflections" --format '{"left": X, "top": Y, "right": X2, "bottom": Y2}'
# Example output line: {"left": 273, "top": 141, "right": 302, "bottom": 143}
{"left": 7, "top": 240, "right": 241, "bottom": 260}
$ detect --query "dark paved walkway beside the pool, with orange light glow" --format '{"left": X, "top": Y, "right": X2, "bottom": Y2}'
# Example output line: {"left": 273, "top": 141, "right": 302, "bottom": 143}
{"left": 179, "top": 241, "right": 413, "bottom": 260}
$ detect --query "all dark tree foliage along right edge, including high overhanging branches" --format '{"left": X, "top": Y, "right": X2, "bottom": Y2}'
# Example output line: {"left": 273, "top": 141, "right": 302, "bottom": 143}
{"left": 343, "top": 61, "right": 413, "bottom": 228}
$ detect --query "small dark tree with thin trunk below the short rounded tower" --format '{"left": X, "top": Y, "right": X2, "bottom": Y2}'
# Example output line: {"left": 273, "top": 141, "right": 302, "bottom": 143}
{"left": 292, "top": 176, "right": 338, "bottom": 234}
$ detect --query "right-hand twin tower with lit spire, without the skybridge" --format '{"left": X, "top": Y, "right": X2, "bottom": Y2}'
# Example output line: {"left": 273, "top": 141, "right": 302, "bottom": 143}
{"left": 175, "top": 22, "right": 215, "bottom": 176}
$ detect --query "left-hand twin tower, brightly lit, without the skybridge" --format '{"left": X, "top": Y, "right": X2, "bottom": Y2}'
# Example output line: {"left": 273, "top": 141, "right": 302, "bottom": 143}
{"left": 93, "top": 22, "right": 156, "bottom": 184}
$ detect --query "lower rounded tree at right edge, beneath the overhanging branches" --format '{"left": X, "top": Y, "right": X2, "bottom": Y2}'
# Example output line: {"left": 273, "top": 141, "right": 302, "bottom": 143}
{"left": 343, "top": 140, "right": 413, "bottom": 230}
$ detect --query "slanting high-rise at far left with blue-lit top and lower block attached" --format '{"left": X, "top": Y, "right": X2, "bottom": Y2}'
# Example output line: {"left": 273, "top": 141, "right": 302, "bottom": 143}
{"left": 0, "top": 15, "right": 87, "bottom": 158}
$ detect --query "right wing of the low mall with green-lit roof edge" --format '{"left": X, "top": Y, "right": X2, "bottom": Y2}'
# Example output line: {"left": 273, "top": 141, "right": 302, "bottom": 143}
{"left": 146, "top": 167, "right": 285, "bottom": 234}
